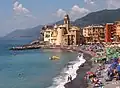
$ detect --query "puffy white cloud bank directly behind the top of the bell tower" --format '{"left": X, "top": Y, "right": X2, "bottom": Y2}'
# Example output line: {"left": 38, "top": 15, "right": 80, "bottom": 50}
{"left": 56, "top": 5, "right": 90, "bottom": 20}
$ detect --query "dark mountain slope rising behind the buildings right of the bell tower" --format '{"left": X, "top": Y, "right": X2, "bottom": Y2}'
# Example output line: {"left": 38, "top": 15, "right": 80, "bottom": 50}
{"left": 73, "top": 9, "right": 120, "bottom": 27}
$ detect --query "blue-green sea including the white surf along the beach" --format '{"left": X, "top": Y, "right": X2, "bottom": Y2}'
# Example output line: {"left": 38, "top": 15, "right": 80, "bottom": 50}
{"left": 0, "top": 40, "right": 85, "bottom": 88}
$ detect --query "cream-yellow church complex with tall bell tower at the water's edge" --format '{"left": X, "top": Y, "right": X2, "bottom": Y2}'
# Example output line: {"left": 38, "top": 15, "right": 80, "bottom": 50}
{"left": 44, "top": 15, "right": 80, "bottom": 45}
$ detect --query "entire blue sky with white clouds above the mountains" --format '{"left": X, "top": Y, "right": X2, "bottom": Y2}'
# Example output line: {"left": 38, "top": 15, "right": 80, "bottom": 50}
{"left": 0, "top": 0, "right": 120, "bottom": 36}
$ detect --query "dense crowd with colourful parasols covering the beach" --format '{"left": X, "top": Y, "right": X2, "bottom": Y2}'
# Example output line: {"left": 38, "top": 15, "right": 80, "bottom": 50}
{"left": 82, "top": 44, "right": 120, "bottom": 88}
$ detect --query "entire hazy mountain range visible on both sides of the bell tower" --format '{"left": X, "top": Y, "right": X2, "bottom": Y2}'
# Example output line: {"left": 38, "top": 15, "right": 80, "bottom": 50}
{"left": 4, "top": 9, "right": 120, "bottom": 40}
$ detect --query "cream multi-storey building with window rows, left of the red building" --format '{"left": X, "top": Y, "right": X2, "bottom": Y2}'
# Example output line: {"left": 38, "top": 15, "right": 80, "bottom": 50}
{"left": 83, "top": 25, "right": 105, "bottom": 43}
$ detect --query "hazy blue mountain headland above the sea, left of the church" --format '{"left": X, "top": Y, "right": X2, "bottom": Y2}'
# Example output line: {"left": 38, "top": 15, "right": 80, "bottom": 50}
{"left": 3, "top": 25, "right": 43, "bottom": 40}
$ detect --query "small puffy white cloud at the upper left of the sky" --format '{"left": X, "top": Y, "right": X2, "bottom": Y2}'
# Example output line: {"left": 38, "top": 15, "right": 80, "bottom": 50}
{"left": 13, "top": 1, "right": 30, "bottom": 14}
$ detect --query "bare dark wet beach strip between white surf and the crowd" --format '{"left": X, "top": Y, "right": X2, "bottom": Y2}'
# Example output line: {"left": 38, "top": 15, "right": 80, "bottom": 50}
{"left": 64, "top": 52, "right": 92, "bottom": 88}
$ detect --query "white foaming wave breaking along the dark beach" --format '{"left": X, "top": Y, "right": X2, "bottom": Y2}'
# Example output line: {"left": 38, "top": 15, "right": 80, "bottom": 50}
{"left": 48, "top": 53, "right": 86, "bottom": 88}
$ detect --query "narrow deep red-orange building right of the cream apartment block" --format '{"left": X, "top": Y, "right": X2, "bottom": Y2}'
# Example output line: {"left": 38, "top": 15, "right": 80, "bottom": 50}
{"left": 105, "top": 23, "right": 115, "bottom": 42}
